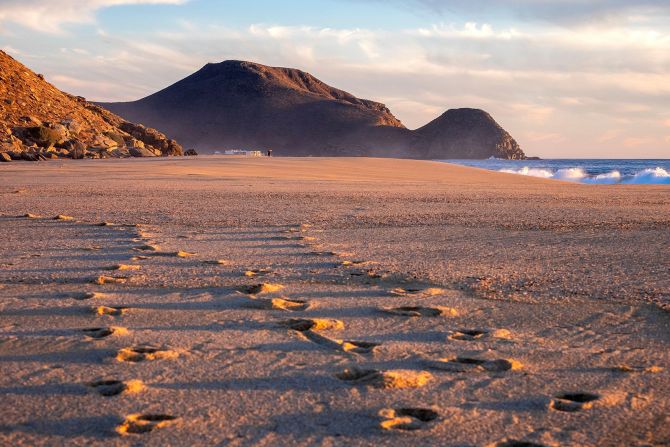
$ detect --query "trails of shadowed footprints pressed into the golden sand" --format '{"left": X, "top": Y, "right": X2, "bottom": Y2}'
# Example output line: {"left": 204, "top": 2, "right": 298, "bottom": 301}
{"left": 23, "top": 214, "right": 620, "bottom": 447}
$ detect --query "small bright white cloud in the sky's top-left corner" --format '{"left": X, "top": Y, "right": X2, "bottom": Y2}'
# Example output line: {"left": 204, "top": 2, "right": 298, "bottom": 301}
{"left": 0, "top": 0, "right": 188, "bottom": 33}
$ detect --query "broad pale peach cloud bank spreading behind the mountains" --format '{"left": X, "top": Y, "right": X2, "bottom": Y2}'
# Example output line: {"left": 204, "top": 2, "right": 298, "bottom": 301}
{"left": 0, "top": 5, "right": 670, "bottom": 157}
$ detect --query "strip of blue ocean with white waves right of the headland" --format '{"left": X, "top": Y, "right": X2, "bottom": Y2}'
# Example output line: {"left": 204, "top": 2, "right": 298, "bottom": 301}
{"left": 438, "top": 158, "right": 670, "bottom": 185}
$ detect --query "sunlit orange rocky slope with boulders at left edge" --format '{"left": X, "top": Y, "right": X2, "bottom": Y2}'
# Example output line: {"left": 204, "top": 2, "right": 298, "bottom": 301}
{"left": 0, "top": 51, "right": 182, "bottom": 161}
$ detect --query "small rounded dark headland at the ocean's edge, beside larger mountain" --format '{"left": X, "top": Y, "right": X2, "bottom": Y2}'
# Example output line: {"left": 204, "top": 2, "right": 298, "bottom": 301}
{"left": 415, "top": 109, "right": 525, "bottom": 160}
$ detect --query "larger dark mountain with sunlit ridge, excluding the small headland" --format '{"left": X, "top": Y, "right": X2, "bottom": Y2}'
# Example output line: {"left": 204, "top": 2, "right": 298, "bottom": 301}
{"left": 104, "top": 61, "right": 402, "bottom": 155}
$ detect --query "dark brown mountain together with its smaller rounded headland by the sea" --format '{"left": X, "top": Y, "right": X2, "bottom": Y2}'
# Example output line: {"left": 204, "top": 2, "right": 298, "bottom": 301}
{"left": 102, "top": 61, "right": 524, "bottom": 158}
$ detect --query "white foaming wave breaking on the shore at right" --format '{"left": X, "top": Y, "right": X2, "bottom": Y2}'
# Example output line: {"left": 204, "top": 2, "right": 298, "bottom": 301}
{"left": 498, "top": 166, "right": 670, "bottom": 185}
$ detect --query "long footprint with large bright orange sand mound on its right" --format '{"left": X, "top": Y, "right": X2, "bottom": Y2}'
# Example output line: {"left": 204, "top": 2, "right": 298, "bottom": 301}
{"left": 335, "top": 367, "right": 433, "bottom": 389}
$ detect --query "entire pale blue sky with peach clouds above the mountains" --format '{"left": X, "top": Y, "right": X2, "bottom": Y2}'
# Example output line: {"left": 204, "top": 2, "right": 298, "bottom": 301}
{"left": 0, "top": 0, "right": 670, "bottom": 158}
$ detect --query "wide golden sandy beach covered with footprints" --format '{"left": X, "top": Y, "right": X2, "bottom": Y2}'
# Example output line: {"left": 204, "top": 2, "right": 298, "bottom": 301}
{"left": 0, "top": 157, "right": 670, "bottom": 446}
